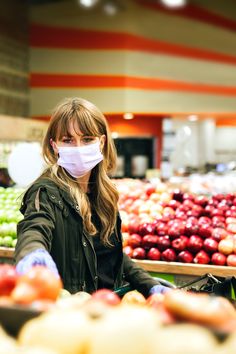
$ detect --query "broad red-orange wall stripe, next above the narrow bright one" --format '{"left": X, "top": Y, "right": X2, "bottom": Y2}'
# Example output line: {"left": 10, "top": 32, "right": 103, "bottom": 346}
{"left": 30, "top": 24, "right": 236, "bottom": 65}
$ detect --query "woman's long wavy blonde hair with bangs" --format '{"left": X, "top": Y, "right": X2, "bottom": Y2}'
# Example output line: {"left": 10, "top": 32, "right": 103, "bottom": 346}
{"left": 40, "top": 97, "right": 118, "bottom": 245}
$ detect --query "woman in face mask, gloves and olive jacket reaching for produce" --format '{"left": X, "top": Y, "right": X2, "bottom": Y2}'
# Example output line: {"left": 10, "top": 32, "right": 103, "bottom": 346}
{"left": 15, "top": 98, "right": 167, "bottom": 296}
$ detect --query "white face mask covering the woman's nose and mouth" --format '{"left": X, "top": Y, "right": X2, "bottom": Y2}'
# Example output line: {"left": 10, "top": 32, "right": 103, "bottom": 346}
{"left": 57, "top": 141, "right": 103, "bottom": 178}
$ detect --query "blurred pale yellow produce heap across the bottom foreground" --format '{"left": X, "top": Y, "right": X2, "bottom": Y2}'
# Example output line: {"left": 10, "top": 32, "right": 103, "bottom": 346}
{"left": 0, "top": 289, "right": 236, "bottom": 354}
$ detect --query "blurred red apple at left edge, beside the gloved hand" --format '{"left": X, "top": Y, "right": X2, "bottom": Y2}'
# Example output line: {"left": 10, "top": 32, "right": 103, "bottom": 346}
{"left": 0, "top": 264, "right": 18, "bottom": 296}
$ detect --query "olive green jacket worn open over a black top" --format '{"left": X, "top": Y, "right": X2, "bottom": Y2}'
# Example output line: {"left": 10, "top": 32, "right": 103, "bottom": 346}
{"left": 15, "top": 178, "right": 157, "bottom": 296}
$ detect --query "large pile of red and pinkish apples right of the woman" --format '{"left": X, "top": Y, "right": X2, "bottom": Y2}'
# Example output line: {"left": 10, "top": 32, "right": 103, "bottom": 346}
{"left": 118, "top": 181, "right": 236, "bottom": 266}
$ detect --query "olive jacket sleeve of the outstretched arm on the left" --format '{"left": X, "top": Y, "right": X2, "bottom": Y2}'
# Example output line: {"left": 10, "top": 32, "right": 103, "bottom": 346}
{"left": 14, "top": 187, "right": 55, "bottom": 263}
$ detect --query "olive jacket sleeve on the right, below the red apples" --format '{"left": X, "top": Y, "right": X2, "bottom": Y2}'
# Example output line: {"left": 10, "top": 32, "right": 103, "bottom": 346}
{"left": 123, "top": 253, "right": 159, "bottom": 296}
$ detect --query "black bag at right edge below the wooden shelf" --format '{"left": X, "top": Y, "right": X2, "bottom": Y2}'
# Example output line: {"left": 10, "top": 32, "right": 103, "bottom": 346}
{"left": 179, "top": 273, "right": 236, "bottom": 302}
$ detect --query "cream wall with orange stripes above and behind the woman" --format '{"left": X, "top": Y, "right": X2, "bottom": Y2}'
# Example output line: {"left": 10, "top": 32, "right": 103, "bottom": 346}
{"left": 30, "top": 0, "right": 236, "bottom": 167}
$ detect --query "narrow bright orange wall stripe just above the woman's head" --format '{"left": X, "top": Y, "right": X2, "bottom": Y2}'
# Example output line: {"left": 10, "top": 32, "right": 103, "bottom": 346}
{"left": 30, "top": 73, "right": 236, "bottom": 96}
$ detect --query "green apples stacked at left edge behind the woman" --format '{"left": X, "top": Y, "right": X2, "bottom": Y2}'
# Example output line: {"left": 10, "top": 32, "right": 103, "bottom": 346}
{"left": 0, "top": 187, "right": 23, "bottom": 247}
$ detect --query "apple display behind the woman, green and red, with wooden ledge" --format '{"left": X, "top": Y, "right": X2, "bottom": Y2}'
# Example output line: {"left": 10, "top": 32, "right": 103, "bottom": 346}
{"left": 0, "top": 179, "right": 236, "bottom": 276}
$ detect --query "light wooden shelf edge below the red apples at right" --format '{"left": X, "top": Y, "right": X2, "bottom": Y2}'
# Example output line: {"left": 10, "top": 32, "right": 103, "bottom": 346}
{"left": 134, "top": 260, "right": 236, "bottom": 277}
